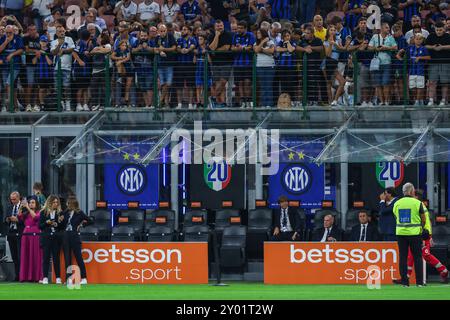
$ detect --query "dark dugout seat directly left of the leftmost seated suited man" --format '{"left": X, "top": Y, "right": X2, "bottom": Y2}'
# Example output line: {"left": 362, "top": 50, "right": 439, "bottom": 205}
{"left": 247, "top": 208, "right": 272, "bottom": 259}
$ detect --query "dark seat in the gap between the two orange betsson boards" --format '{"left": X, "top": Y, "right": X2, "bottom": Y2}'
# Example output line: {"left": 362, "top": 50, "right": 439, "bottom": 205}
{"left": 220, "top": 225, "right": 247, "bottom": 269}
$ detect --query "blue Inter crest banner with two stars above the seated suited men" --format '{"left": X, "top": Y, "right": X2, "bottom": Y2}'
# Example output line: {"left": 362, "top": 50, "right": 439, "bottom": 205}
{"left": 269, "top": 138, "right": 326, "bottom": 209}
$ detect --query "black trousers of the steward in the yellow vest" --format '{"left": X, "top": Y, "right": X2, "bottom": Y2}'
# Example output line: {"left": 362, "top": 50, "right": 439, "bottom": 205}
{"left": 397, "top": 235, "right": 423, "bottom": 285}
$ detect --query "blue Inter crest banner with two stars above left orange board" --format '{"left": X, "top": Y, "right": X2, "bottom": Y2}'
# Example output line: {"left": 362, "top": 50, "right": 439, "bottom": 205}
{"left": 104, "top": 141, "right": 159, "bottom": 209}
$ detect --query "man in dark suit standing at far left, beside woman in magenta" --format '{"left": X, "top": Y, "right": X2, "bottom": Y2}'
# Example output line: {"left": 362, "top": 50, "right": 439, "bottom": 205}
{"left": 4, "top": 191, "right": 24, "bottom": 281}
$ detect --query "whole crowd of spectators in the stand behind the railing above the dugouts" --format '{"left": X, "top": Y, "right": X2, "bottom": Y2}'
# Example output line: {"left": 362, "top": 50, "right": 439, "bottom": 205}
{"left": 0, "top": 0, "right": 450, "bottom": 112}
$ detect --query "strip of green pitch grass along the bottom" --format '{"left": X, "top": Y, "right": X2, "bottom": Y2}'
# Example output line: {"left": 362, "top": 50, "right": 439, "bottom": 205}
{"left": 0, "top": 282, "right": 450, "bottom": 300}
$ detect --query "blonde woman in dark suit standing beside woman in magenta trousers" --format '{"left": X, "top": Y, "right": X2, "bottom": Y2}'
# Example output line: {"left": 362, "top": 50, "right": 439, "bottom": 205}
{"left": 39, "top": 195, "right": 62, "bottom": 284}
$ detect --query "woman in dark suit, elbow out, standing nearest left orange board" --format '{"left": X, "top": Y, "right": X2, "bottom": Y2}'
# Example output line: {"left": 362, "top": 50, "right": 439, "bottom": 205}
{"left": 60, "top": 196, "right": 91, "bottom": 284}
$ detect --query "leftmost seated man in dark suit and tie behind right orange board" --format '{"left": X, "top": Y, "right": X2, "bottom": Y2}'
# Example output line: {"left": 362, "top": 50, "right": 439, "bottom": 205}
{"left": 271, "top": 196, "right": 304, "bottom": 241}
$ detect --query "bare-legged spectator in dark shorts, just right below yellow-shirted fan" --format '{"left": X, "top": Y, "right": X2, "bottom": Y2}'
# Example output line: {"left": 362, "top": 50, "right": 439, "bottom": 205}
{"left": 323, "top": 25, "right": 348, "bottom": 106}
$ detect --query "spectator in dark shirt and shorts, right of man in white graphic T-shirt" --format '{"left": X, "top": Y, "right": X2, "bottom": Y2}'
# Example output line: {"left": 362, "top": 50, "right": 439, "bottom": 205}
{"left": 72, "top": 30, "right": 94, "bottom": 111}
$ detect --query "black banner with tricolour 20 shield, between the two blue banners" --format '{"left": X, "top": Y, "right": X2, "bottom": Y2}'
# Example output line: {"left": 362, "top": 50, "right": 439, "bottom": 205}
{"left": 188, "top": 158, "right": 245, "bottom": 209}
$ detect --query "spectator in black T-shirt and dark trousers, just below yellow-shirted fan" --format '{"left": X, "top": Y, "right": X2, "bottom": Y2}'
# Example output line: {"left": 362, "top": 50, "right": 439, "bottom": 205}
{"left": 299, "top": 27, "right": 323, "bottom": 105}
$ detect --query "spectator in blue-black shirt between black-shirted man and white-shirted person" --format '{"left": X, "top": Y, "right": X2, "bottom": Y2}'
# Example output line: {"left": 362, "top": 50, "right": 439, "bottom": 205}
{"left": 231, "top": 21, "right": 255, "bottom": 108}
